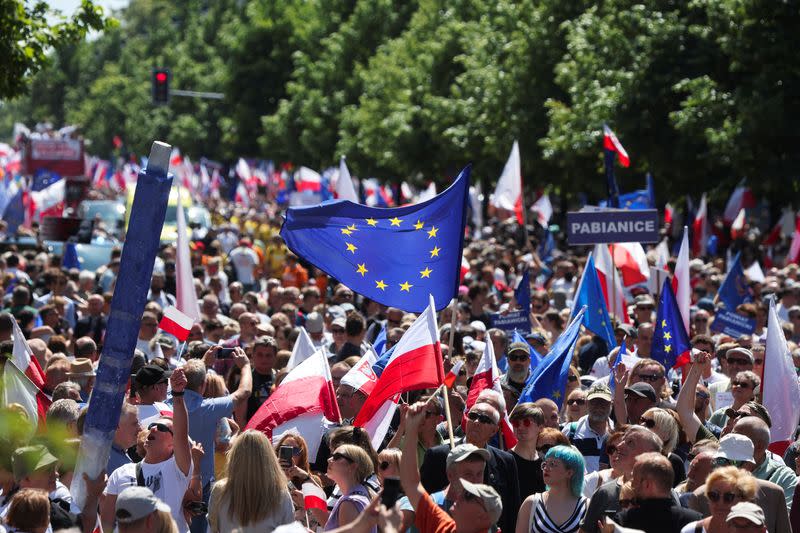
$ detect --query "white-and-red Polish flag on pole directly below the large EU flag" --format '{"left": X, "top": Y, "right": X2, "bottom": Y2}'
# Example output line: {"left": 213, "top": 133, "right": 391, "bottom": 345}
{"left": 353, "top": 297, "right": 444, "bottom": 427}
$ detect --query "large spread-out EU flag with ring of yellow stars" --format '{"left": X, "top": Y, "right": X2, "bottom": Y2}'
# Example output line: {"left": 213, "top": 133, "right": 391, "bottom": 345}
{"left": 281, "top": 166, "right": 470, "bottom": 313}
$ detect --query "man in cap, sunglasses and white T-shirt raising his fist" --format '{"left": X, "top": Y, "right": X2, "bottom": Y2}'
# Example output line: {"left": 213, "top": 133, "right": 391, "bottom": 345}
{"left": 100, "top": 368, "right": 192, "bottom": 533}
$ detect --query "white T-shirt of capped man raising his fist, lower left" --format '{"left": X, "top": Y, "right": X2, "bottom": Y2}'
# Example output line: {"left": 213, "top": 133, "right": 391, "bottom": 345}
{"left": 104, "top": 455, "right": 192, "bottom": 533}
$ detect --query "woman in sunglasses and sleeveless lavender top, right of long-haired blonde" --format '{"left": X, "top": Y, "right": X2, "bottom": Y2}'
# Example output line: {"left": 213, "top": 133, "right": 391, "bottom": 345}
{"left": 324, "top": 444, "right": 378, "bottom": 533}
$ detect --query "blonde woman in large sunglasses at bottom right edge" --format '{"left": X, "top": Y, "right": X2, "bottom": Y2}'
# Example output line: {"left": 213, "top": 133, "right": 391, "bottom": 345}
{"left": 681, "top": 466, "right": 758, "bottom": 533}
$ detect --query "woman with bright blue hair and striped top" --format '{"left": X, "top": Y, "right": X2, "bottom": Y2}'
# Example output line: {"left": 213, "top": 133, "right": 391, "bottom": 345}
{"left": 516, "top": 446, "right": 589, "bottom": 533}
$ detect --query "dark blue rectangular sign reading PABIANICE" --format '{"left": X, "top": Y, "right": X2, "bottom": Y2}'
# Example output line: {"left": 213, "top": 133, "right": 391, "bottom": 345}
{"left": 567, "top": 208, "right": 659, "bottom": 246}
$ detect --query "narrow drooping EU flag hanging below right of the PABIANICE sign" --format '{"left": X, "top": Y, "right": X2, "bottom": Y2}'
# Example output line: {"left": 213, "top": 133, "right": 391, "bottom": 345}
{"left": 650, "top": 279, "right": 692, "bottom": 369}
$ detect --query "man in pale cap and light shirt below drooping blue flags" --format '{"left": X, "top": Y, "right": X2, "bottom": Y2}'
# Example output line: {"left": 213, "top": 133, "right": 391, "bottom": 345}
{"left": 563, "top": 384, "right": 613, "bottom": 474}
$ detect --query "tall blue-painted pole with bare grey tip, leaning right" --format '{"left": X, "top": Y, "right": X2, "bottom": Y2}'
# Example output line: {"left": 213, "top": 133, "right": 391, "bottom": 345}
{"left": 70, "top": 141, "right": 172, "bottom": 508}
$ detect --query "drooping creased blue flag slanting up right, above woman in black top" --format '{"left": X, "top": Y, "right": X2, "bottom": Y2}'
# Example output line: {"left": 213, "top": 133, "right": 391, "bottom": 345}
{"left": 518, "top": 307, "right": 587, "bottom": 409}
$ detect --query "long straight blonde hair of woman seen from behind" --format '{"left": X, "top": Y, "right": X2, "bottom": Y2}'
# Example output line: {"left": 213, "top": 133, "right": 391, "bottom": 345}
{"left": 208, "top": 430, "right": 287, "bottom": 530}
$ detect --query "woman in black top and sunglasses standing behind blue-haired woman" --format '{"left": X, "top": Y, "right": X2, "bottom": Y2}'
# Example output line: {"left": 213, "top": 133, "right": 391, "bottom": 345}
{"left": 509, "top": 402, "right": 545, "bottom": 499}
